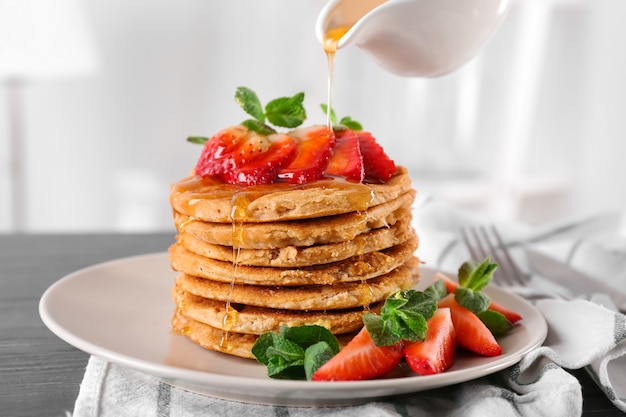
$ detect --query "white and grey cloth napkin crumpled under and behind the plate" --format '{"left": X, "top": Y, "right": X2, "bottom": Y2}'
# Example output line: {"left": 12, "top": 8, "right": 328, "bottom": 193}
{"left": 73, "top": 198, "right": 626, "bottom": 417}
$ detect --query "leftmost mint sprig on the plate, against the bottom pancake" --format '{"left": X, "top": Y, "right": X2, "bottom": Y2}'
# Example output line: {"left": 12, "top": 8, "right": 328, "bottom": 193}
{"left": 252, "top": 325, "right": 339, "bottom": 380}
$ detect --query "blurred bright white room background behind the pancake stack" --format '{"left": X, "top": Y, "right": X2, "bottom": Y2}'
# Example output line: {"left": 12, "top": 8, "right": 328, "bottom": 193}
{"left": 0, "top": 0, "right": 626, "bottom": 232}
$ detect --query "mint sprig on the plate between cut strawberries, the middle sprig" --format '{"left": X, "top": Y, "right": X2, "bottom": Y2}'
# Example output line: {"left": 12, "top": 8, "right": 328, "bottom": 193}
{"left": 363, "top": 290, "right": 437, "bottom": 346}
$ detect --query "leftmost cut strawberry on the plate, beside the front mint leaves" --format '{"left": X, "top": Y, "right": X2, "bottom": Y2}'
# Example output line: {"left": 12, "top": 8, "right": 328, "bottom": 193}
{"left": 313, "top": 327, "right": 402, "bottom": 381}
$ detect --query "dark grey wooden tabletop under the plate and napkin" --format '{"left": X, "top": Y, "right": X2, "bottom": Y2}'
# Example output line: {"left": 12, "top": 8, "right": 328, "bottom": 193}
{"left": 0, "top": 232, "right": 624, "bottom": 417}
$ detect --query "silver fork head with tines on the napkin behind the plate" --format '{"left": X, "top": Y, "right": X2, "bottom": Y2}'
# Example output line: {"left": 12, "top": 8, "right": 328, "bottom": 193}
{"left": 461, "top": 225, "right": 526, "bottom": 286}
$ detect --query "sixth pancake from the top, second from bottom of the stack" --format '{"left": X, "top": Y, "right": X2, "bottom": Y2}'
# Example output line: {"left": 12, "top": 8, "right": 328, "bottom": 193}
{"left": 172, "top": 287, "right": 382, "bottom": 335}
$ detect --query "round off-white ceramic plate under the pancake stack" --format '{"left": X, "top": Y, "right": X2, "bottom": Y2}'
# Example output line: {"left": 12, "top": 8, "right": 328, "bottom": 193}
{"left": 39, "top": 253, "right": 547, "bottom": 406}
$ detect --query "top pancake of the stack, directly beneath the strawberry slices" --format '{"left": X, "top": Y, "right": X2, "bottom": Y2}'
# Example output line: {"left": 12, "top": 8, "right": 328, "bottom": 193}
{"left": 170, "top": 167, "right": 411, "bottom": 223}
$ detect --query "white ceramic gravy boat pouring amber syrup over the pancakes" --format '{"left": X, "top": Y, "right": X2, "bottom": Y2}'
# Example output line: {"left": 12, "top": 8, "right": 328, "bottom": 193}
{"left": 316, "top": 0, "right": 511, "bottom": 77}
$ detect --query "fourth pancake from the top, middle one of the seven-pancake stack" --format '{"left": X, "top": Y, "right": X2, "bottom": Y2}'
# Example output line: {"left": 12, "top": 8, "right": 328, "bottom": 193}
{"left": 170, "top": 239, "right": 417, "bottom": 286}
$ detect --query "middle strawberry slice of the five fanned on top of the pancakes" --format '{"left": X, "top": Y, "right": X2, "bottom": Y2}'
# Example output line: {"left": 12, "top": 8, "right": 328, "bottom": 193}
{"left": 278, "top": 126, "right": 335, "bottom": 184}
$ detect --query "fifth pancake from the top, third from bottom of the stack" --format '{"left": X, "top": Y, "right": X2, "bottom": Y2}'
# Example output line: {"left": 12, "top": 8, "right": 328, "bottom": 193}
{"left": 176, "top": 258, "right": 419, "bottom": 310}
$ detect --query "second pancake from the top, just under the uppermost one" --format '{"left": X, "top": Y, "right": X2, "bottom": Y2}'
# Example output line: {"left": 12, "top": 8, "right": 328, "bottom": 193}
{"left": 174, "top": 190, "right": 415, "bottom": 249}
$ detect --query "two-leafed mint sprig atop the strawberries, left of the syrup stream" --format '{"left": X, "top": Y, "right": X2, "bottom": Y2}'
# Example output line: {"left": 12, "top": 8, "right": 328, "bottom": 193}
{"left": 235, "top": 87, "right": 306, "bottom": 135}
